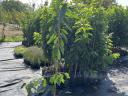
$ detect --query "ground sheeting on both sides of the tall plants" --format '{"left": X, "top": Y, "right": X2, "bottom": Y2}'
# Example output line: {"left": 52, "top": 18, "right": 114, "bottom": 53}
{"left": 0, "top": 42, "right": 128, "bottom": 96}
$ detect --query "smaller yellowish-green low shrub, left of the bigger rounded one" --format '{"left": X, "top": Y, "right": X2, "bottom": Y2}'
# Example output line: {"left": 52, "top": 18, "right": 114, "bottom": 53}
{"left": 14, "top": 46, "right": 26, "bottom": 58}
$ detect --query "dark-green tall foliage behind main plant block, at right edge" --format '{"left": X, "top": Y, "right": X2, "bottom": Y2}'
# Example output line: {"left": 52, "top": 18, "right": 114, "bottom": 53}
{"left": 108, "top": 6, "right": 128, "bottom": 47}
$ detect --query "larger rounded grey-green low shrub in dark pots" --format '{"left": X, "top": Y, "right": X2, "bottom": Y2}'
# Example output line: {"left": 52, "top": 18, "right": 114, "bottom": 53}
{"left": 23, "top": 46, "right": 47, "bottom": 69}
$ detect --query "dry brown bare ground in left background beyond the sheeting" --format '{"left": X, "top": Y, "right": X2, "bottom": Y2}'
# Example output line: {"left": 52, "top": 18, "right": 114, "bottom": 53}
{"left": 0, "top": 24, "right": 23, "bottom": 37}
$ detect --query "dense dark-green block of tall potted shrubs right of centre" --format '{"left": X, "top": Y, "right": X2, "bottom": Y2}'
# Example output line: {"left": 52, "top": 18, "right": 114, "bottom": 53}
{"left": 65, "top": 4, "right": 111, "bottom": 81}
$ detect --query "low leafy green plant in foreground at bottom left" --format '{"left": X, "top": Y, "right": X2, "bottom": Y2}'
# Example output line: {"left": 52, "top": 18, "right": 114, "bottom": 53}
{"left": 23, "top": 73, "right": 70, "bottom": 96}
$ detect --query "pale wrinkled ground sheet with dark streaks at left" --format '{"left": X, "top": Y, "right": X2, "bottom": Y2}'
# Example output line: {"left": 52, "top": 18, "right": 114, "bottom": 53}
{"left": 0, "top": 43, "right": 41, "bottom": 96}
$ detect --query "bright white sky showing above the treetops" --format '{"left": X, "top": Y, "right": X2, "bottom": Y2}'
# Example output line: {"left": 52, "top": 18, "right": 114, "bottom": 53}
{"left": 20, "top": 0, "right": 128, "bottom": 6}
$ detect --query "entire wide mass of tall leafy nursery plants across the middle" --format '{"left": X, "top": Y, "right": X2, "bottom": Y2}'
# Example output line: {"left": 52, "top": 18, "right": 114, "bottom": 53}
{"left": 21, "top": 1, "right": 112, "bottom": 78}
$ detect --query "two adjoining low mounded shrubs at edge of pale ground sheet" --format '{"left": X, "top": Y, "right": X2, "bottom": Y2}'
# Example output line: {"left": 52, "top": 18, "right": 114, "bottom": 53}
{"left": 14, "top": 46, "right": 48, "bottom": 69}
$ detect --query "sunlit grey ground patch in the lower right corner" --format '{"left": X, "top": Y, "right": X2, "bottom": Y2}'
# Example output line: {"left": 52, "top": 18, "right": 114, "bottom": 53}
{"left": 108, "top": 67, "right": 128, "bottom": 96}
